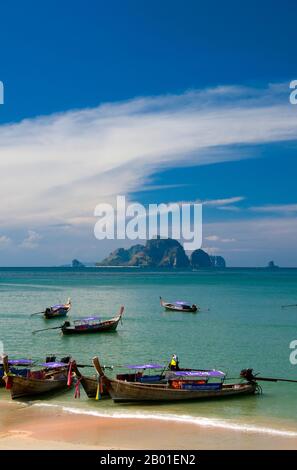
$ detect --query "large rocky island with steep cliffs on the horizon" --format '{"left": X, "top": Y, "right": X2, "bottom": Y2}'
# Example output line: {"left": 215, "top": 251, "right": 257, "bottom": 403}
{"left": 96, "top": 238, "right": 226, "bottom": 268}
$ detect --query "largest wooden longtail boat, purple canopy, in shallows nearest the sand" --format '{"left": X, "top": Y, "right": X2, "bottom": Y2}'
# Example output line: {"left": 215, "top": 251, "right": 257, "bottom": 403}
{"left": 93, "top": 357, "right": 258, "bottom": 402}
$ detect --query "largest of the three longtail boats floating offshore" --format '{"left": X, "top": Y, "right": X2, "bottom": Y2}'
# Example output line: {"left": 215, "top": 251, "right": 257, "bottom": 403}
{"left": 33, "top": 306, "right": 124, "bottom": 335}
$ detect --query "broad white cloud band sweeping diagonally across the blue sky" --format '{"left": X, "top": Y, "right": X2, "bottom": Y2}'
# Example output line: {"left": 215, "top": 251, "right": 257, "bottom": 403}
{"left": 0, "top": 82, "right": 296, "bottom": 235}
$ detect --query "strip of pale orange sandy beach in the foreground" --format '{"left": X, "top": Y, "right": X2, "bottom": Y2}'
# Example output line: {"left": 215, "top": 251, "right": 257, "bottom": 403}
{"left": 0, "top": 401, "right": 297, "bottom": 450}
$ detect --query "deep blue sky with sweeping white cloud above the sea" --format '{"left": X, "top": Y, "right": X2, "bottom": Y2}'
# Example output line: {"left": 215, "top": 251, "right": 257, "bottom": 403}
{"left": 0, "top": 0, "right": 297, "bottom": 266}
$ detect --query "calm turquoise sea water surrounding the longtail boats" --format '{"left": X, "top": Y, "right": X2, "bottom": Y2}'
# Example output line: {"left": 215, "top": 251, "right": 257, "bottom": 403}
{"left": 0, "top": 268, "right": 297, "bottom": 432}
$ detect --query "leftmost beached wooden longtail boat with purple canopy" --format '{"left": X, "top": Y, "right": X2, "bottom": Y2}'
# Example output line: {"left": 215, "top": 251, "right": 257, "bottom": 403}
{"left": 3, "top": 356, "right": 72, "bottom": 399}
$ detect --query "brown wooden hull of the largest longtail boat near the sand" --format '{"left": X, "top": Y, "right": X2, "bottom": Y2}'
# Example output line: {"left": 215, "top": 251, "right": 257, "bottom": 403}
{"left": 106, "top": 379, "right": 257, "bottom": 402}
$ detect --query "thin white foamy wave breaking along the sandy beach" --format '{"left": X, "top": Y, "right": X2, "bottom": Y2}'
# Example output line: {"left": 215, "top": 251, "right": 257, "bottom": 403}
{"left": 32, "top": 403, "right": 297, "bottom": 438}
